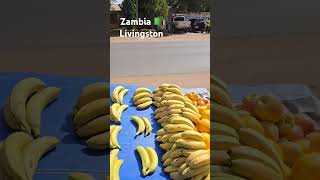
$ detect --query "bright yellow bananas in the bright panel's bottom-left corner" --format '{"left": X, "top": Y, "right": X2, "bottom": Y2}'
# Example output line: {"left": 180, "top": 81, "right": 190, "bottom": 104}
{"left": 110, "top": 149, "right": 123, "bottom": 180}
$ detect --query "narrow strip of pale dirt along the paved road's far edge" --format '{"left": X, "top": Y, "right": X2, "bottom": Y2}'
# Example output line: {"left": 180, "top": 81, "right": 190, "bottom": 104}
{"left": 110, "top": 33, "right": 210, "bottom": 43}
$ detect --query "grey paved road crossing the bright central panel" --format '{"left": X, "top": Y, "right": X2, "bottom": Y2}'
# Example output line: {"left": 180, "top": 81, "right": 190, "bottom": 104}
{"left": 110, "top": 40, "right": 210, "bottom": 77}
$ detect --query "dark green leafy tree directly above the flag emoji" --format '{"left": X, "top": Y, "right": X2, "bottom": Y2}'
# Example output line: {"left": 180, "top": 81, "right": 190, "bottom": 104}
{"left": 139, "top": 0, "right": 169, "bottom": 19}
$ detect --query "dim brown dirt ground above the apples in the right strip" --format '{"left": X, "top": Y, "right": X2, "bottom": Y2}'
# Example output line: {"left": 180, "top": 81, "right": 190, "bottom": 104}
{"left": 211, "top": 33, "right": 320, "bottom": 97}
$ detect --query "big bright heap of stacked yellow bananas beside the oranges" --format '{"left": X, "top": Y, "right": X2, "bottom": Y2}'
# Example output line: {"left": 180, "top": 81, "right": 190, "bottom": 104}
{"left": 153, "top": 84, "right": 210, "bottom": 179}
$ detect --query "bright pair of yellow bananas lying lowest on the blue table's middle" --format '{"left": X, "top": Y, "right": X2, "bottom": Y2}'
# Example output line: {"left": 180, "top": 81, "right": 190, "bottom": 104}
{"left": 136, "top": 146, "right": 158, "bottom": 176}
